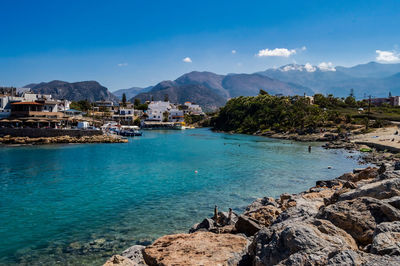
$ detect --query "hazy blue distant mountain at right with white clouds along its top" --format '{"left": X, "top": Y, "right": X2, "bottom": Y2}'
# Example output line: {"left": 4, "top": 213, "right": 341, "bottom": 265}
{"left": 258, "top": 62, "right": 400, "bottom": 98}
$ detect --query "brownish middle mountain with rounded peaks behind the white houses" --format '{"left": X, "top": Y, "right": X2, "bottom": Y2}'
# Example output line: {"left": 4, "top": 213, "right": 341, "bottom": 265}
{"left": 131, "top": 71, "right": 313, "bottom": 110}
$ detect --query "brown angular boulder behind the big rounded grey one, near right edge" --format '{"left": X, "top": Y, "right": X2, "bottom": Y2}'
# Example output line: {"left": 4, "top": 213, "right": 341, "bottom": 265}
{"left": 318, "top": 197, "right": 400, "bottom": 245}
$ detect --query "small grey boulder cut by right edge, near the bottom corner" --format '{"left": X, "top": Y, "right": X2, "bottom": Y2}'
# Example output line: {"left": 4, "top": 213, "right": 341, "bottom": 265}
{"left": 371, "top": 221, "right": 400, "bottom": 256}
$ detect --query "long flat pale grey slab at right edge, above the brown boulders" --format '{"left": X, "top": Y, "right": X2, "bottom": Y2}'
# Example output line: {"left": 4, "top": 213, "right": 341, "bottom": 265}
{"left": 339, "top": 178, "right": 400, "bottom": 200}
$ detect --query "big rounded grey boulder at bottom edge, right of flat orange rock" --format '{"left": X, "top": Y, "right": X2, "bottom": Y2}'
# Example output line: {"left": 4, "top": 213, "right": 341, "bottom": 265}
{"left": 253, "top": 219, "right": 357, "bottom": 265}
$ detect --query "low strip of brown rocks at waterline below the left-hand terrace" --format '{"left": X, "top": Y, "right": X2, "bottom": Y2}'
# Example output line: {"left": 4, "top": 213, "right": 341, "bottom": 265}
{"left": 0, "top": 135, "right": 128, "bottom": 145}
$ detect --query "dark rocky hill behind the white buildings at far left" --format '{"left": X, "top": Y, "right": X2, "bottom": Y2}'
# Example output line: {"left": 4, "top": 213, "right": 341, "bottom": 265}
{"left": 25, "top": 80, "right": 118, "bottom": 101}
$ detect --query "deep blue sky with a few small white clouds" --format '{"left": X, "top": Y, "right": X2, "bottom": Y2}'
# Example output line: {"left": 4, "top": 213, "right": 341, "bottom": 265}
{"left": 0, "top": 0, "right": 400, "bottom": 91}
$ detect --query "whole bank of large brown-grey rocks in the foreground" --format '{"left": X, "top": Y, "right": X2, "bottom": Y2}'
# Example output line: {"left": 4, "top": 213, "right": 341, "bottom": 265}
{"left": 106, "top": 164, "right": 400, "bottom": 265}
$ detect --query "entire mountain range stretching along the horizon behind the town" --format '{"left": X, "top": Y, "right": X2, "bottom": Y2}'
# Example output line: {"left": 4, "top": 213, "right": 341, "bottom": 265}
{"left": 25, "top": 62, "right": 400, "bottom": 110}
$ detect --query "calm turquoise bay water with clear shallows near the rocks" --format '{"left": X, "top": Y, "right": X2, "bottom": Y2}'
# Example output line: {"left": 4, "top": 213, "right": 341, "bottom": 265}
{"left": 0, "top": 129, "right": 357, "bottom": 265}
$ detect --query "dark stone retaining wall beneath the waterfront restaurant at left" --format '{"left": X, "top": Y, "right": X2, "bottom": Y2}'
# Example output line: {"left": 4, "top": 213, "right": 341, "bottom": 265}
{"left": 0, "top": 128, "right": 103, "bottom": 138}
